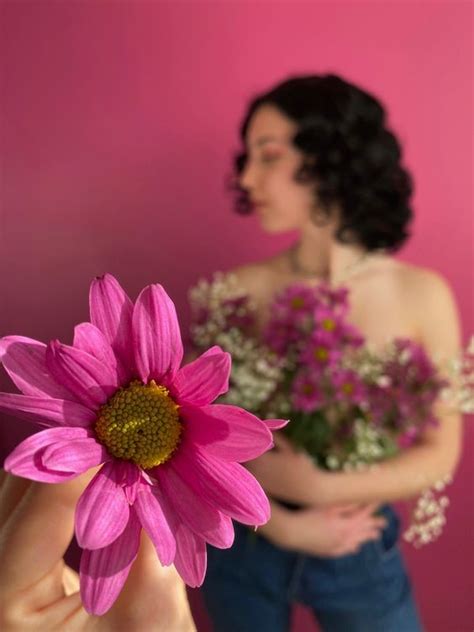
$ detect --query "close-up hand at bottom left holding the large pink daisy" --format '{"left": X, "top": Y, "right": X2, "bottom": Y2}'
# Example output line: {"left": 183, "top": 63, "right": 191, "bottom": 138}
{"left": 0, "top": 472, "right": 196, "bottom": 632}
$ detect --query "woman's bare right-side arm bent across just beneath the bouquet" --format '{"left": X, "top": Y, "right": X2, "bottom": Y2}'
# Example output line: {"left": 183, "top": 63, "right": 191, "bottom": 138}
{"left": 249, "top": 275, "right": 461, "bottom": 506}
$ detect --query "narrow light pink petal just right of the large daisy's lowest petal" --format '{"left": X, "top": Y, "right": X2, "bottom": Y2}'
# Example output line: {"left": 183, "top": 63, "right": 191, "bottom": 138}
{"left": 134, "top": 482, "right": 176, "bottom": 566}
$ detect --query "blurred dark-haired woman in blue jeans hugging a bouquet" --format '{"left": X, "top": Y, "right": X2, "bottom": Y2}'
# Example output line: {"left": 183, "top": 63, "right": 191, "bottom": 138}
{"left": 198, "top": 75, "right": 461, "bottom": 632}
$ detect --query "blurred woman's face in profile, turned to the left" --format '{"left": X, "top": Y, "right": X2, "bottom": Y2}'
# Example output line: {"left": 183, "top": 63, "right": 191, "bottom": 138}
{"left": 239, "top": 105, "right": 315, "bottom": 233}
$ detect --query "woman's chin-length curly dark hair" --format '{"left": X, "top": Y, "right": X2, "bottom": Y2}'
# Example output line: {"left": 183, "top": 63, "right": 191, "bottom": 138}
{"left": 228, "top": 74, "right": 413, "bottom": 251}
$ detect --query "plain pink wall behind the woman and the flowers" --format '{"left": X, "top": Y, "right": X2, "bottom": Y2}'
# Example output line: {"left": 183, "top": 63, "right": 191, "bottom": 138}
{"left": 0, "top": 0, "right": 474, "bottom": 632}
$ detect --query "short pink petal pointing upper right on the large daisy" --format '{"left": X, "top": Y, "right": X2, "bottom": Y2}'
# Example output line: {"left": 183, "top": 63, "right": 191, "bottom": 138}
{"left": 172, "top": 345, "right": 231, "bottom": 406}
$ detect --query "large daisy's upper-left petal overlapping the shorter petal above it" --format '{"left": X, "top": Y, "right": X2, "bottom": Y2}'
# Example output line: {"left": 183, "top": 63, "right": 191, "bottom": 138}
{"left": 46, "top": 340, "right": 118, "bottom": 409}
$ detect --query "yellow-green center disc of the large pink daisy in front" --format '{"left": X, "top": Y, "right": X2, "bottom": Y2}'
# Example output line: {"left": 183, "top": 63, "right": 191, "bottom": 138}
{"left": 95, "top": 380, "right": 182, "bottom": 469}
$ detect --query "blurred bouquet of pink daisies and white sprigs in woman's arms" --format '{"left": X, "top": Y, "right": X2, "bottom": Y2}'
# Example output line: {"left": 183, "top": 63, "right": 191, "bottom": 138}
{"left": 190, "top": 273, "right": 473, "bottom": 540}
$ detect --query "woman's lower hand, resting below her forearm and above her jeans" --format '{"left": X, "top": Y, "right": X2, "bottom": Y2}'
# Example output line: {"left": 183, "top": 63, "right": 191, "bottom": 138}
{"left": 267, "top": 505, "right": 386, "bottom": 557}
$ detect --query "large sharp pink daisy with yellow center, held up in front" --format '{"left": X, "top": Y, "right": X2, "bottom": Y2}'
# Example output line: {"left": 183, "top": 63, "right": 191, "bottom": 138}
{"left": 0, "top": 274, "right": 285, "bottom": 614}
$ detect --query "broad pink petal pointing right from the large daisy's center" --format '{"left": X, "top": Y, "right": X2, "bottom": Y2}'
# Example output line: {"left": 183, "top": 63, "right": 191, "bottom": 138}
{"left": 180, "top": 404, "right": 273, "bottom": 462}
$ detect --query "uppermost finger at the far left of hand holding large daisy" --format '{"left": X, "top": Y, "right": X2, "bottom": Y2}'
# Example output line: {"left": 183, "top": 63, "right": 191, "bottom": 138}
{"left": 0, "top": 470, "right": 95, "bottom": 592}
